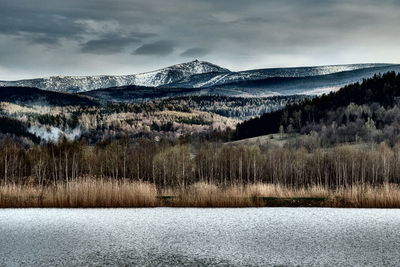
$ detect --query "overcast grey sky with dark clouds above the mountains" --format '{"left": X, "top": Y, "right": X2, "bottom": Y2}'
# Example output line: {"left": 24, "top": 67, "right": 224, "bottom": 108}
{"left": 0, "top": 0, "right": 400, "bottom": 80}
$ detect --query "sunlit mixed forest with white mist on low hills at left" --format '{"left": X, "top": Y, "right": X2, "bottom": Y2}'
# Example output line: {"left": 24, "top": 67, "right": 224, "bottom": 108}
{"left": 0, "top": 101, "right": 238, "bottom": 146}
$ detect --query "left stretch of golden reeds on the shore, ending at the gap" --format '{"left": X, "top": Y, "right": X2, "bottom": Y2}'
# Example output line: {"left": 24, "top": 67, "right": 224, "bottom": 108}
{"left": 0, "top": 178, "right": 157, "bottom": 208}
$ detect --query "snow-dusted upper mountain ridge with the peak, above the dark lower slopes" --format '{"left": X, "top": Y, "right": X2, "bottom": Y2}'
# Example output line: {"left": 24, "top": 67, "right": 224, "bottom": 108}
{"left": 0, "top": 60, "right": 400, "bottom": 93}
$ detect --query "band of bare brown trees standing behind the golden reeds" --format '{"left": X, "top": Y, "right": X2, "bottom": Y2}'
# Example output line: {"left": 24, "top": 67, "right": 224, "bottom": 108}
{"left": 0, "top": 139, "right": 400, "bottom": 191}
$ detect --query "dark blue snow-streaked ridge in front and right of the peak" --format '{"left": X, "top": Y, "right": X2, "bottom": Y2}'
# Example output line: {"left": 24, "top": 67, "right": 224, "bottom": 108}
{"left": 79, "top": 64, "right": 400, "bottom": 103}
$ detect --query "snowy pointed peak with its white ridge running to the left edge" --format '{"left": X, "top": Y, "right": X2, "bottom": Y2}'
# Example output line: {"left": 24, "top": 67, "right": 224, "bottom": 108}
{"left": 0, "top": 60, "right": 230, "bottom": 93}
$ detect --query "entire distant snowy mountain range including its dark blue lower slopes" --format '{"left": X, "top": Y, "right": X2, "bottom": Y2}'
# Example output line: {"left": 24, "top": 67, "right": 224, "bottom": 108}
{"left": 0, "top": 60, "right": 400, "bottom": 98}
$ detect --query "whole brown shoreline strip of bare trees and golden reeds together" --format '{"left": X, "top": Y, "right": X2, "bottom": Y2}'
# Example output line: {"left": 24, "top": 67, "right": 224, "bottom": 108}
{"left": 0, "top": 139, "right": 400, "bottom": 208}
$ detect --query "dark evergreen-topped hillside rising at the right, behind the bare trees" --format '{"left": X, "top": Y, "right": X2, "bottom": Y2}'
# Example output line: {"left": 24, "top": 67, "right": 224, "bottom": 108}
{"left": 235, "top": 72, "right": 400, "bottom": 145}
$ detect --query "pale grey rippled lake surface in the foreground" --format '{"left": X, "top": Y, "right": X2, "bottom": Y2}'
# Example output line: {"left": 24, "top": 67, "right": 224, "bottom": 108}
{"left": 0, "top": 208, "right": 400, "bottom": 266}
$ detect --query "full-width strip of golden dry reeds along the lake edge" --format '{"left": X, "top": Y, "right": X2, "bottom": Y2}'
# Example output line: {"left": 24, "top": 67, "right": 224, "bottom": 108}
{"left": 0, "top": 178, "right": 400, "bottom": 208}
